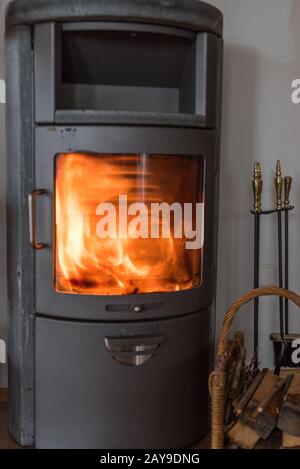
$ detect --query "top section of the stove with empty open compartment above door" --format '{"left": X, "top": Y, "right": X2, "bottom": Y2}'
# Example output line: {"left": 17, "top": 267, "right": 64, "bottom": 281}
{"left": 7, "top": 0, "right": 223, "bottom": 128}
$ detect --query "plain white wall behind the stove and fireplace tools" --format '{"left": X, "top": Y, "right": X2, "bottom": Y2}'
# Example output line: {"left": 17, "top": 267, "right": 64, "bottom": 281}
{"left": 0, "top": 0, "right": 300, "bottom": 386}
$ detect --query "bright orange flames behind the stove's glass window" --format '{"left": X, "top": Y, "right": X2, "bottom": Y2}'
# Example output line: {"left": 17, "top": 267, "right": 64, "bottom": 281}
{"left": 55, "top": 153, "right": 203, "bottom": 295}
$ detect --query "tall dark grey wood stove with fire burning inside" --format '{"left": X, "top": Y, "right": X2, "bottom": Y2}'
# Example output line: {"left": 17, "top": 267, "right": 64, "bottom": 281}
{"left": 6, "top": 0, "right": 222, "bottom": 448}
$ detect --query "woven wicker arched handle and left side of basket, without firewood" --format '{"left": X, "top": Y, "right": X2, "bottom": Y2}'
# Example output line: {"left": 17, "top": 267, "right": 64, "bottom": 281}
{"left": 209, "top": 287, "right": 300, "bottom": 449}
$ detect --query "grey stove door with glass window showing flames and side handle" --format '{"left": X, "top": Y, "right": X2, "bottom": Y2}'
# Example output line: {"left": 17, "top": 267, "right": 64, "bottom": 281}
{"left": 35, "top": 127, "right": 217, "bottom": 320}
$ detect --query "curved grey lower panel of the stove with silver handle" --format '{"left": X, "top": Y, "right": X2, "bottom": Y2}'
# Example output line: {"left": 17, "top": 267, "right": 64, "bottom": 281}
{"left": 35, "top": 311, "right": 210, "bottom": 449}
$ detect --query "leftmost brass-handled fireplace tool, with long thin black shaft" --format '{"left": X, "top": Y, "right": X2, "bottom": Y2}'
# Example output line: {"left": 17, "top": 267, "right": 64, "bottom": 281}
{"left": 253, "top": 163, "right": 263, "bottom": 367}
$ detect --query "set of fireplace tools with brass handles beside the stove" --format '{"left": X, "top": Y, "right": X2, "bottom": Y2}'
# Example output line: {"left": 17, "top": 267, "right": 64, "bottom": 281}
{"left": 251, "top": 161, "right": 296, "bottom": 374}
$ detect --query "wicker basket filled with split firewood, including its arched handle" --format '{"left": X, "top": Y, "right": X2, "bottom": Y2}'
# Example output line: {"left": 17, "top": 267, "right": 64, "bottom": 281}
{"left": 209, "top": 287, "right": 300, "bottom": 449}
